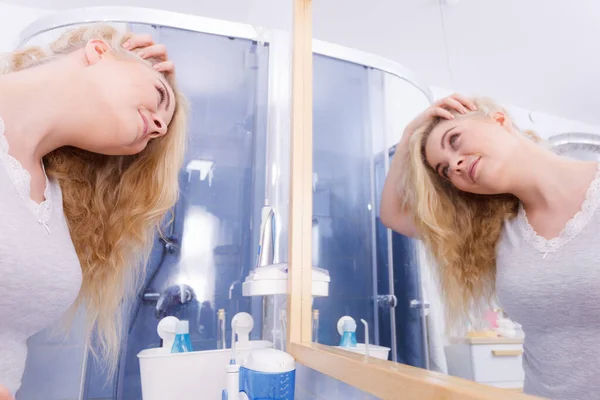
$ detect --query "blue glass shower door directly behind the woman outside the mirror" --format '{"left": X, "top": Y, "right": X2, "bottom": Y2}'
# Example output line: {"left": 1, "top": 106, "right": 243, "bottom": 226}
{"left": 84, "top": 25, "right": 268, "bottom": 400}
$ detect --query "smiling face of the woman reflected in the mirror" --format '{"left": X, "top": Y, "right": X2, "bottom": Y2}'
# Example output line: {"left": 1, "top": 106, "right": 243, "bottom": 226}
{"left": 425, "top": 113, "right": 519, "bottom": 194}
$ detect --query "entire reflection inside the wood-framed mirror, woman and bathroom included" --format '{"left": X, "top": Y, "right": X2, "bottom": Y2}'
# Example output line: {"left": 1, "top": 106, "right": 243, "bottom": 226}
{"left": 313, "top": 0, "right": 600, "bottom": 399}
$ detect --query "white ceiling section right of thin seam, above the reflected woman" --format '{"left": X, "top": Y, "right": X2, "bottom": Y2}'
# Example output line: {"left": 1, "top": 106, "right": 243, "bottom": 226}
{"left": 443, "top": 0, "right": 600, "bottom": 124}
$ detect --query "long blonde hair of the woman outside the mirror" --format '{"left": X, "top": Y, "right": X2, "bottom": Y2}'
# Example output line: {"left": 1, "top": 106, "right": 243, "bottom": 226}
{"left": 6, "top": 24, "right": 187, "bottom": 376}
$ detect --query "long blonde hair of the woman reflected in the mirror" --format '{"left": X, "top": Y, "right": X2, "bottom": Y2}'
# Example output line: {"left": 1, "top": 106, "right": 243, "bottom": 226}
{"left": 398, "top": 98, "right": 540, "bottom": 334}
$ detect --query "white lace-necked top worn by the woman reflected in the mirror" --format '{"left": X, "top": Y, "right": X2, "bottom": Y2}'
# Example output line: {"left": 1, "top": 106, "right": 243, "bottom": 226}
{"left": 496, "top": 166, "right": 600, "bottom": 400}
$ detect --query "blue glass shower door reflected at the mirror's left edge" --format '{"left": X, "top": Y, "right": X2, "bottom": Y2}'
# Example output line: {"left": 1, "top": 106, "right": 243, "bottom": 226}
{"left": 313, "top": 55, "right": 378, "bottom": 346}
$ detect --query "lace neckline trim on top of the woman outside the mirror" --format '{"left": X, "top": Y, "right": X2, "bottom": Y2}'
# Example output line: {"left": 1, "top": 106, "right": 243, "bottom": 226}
{"left": 0, "top": 118, "right": 52, "bottom": 231}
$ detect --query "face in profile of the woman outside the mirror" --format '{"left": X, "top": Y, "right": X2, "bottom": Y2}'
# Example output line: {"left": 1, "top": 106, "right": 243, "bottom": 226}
{"left": 79, "top": 40, "right": 175, "bottom": 155}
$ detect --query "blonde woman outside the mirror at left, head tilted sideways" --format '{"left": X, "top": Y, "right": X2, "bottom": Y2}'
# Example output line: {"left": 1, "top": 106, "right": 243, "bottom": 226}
{"left": 0, "top": 25, "right": 186, "bottom": 398}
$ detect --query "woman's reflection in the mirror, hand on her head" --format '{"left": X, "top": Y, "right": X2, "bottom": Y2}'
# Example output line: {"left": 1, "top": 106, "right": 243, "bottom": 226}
{"left": 381, "top": 95, "right": 600, "bottom": 400}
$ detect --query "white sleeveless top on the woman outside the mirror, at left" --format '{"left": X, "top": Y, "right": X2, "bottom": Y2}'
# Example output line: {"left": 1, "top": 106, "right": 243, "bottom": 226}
{"left": 0, "top": 119, "right": 81, "bottom": 396}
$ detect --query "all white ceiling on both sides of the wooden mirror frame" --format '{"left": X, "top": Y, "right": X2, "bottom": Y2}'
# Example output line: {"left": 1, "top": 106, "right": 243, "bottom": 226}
{"left": 0, "top": 0, "right": 600, "bottom": 125}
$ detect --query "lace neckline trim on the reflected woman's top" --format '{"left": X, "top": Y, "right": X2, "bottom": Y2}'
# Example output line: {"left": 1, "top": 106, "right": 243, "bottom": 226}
{"left": 518, "top": 163, "right": 600, "bottom": 254}
